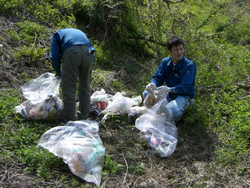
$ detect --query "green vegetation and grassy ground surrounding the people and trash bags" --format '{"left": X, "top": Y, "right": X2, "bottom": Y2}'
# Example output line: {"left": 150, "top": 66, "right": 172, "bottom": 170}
{"left": 0, "top": 0, "right": 250, "bottom": 188}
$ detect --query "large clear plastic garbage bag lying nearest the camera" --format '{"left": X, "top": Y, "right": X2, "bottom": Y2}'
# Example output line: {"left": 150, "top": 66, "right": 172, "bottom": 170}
{"left": 38, "top": 120, "right": 105, "bottom": 186}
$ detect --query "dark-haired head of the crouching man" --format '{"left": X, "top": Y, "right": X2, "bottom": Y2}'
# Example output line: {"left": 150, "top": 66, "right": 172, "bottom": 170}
{"left": 167, "top": 36, "right": 184, "bottom": 64}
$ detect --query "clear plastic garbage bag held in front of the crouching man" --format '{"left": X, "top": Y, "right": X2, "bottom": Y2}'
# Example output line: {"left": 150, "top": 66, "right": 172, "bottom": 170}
{"left": 135, "top": 97, "right": 178, "bottom": 157}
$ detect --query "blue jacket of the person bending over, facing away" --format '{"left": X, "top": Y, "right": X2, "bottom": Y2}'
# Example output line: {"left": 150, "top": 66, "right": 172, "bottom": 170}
{"left": 49, "top": 28, "right": 92, "bottom": 73}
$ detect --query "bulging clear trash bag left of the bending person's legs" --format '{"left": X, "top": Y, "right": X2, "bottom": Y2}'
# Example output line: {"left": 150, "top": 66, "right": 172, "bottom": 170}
{"left": 16, "top": 72, "right": 63, "bottom": 120}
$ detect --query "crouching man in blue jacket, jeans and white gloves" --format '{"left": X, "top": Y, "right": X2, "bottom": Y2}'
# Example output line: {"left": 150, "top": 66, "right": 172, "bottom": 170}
{"left": 143, "top": 36, "right": 196, "bottom": 122}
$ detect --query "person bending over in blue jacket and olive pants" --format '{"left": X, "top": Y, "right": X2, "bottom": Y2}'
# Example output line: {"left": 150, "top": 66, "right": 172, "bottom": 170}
{"left": 49, "top": 28, "right": 95, "bottom": 123}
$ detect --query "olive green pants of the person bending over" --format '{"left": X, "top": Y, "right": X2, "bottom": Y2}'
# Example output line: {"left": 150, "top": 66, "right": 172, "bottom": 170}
{"left": 61, "top": 45, "right": 94, "bottom": 123}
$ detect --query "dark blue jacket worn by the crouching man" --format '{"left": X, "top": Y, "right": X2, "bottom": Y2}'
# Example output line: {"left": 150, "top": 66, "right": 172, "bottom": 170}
{"left": 151, "top": 56, "right": 196, "bottom": 100}
